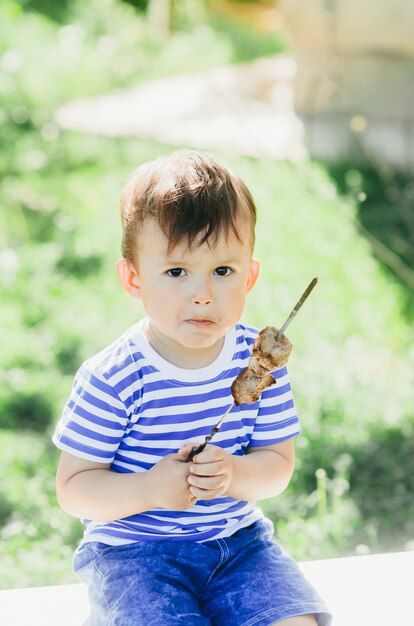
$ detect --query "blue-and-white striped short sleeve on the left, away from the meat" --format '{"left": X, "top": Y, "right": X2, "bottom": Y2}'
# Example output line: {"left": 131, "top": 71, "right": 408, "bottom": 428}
{"left": 52, "top": 365, "right": 128, "bottom": 463}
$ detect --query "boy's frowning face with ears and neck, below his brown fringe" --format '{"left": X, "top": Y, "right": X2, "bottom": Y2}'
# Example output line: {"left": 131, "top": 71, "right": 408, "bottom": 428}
{"left": 118, "top": 220, "right": 259, "bottom": 366}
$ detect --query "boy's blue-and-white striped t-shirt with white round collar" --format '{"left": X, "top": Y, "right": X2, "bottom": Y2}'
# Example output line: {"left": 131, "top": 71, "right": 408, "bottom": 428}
{"left": 53, "top": 320, "right": 299, "bottom": 545}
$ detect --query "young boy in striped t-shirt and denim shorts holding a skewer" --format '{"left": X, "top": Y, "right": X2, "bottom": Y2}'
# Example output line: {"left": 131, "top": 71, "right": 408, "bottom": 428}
{"left": 54, "top": 150, "right": 331, "bottom": 626}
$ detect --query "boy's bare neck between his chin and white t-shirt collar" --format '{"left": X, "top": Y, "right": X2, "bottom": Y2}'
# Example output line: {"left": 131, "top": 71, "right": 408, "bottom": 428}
{"left": 144, "top": 320, "right": 224, "bottom": 370}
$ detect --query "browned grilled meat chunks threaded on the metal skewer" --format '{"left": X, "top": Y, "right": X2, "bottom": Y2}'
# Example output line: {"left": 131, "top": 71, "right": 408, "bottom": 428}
{"left": 231, "top": 326, "right": 293, "bottom": 406}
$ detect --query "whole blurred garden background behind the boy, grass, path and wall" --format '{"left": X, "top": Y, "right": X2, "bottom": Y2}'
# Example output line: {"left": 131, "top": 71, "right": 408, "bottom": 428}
{"left": 0, "top": 0, "right": 414, "bottom": 588}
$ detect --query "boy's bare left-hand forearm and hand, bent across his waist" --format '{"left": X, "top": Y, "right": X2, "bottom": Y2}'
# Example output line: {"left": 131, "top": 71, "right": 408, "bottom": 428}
{"left": 56, "top": 450, "right": 195, "bottom": 521}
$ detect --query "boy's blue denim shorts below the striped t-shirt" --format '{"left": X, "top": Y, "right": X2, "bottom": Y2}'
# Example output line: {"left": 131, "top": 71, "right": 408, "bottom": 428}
{"left": 73, "top": 521, "right": 331, "bottom": 626}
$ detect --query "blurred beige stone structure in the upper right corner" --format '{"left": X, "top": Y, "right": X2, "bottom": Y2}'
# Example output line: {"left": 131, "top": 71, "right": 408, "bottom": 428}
{"left": 278, "top": 0, "right": 414, "bottom": 172}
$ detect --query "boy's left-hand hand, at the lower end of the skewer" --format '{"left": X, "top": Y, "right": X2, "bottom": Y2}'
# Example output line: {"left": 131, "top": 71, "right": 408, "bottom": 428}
{"left": 148, "top": 446, "right": 197, "bottom": 511}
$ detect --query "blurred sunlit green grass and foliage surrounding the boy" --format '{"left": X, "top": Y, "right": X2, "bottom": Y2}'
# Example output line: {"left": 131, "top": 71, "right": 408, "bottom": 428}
{"left": 0, "top": 0, "right": 414, "bottom": 587}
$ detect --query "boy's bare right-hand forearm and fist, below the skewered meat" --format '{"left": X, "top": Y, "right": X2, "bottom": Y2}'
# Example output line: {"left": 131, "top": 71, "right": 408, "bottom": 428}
{"left": 188, "top": 439, "right": 295, "bottom": 500}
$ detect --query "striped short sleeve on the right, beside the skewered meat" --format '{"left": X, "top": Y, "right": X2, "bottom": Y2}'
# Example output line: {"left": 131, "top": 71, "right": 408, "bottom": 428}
{"left": 249, "top": 367, "right": 300, "bottom": 447}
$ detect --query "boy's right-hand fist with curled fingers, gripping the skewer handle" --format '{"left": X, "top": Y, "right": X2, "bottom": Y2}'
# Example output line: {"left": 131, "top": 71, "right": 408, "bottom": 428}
{"left": 184, "top": 444, "right": 233, "bottom": 500}
